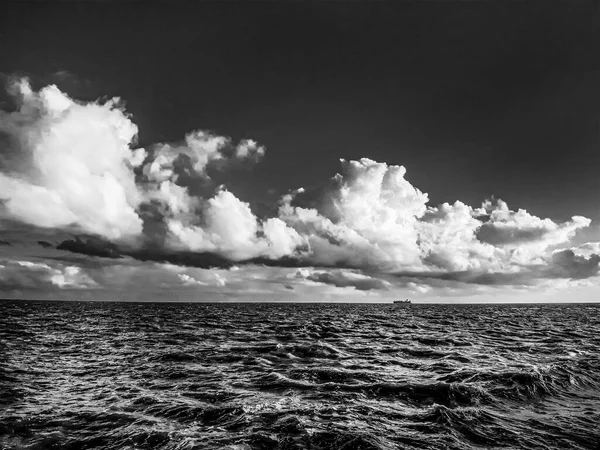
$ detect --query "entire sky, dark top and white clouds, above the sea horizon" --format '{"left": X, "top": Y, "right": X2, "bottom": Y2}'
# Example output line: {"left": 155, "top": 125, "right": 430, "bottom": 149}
{"left": 0, "top": 0, "right": 600, "bottom": 303}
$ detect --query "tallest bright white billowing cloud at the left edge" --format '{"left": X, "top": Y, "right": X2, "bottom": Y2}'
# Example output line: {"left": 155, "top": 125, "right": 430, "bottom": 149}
{"left": 0, "top": 80, "right": 142, "bottom": 239}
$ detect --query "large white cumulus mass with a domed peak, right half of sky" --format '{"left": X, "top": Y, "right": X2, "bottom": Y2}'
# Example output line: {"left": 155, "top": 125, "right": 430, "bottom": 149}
{"left": 280, "top": 159, "right": 590, "bottom": 277}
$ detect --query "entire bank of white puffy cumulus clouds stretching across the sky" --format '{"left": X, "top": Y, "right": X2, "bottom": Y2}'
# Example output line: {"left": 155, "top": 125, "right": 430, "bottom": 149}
{"left": 0, "top": 80, "right": 600, "bottom": 292}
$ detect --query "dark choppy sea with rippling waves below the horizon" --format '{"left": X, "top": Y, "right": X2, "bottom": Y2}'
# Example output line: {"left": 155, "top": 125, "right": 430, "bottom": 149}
{"left": 0, "top": 302, "right": 600, "bottom": 450}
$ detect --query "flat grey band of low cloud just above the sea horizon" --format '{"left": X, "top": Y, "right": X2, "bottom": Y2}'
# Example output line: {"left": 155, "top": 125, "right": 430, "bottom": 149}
{"left": 0, "top": 246, "right": 600, "bottom": 301}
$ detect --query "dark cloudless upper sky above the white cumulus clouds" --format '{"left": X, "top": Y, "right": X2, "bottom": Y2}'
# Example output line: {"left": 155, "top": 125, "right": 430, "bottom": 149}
{"left": 0, "top": 0, "right": 600, "bottom": 219}
